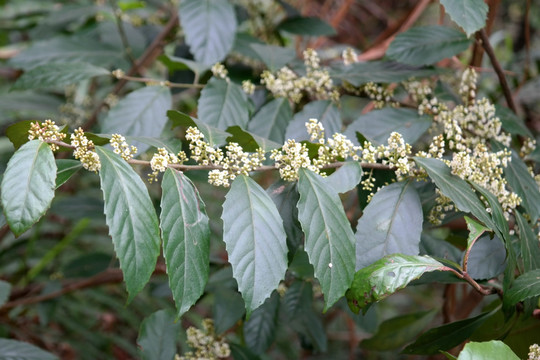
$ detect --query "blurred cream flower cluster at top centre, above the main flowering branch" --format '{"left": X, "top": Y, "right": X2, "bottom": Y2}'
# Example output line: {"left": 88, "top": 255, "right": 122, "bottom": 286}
{"left": 261, "top": 49, "right": 339, "bottom": 103}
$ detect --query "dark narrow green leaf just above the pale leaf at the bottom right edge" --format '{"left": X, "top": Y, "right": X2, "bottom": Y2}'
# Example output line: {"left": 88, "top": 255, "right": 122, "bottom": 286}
{"left": 402, "top": 311, "right": 495, "bottom": 355}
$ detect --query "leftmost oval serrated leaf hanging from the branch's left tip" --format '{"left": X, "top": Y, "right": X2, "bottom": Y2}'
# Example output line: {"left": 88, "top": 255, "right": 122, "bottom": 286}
{"left": 2, "top": 140, "right": 56, "bottom": 236}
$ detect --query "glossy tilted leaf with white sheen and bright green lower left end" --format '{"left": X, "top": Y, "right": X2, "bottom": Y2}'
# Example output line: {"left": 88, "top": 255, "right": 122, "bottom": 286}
{"left": 347, "top": 254, "right": 444, "bottom": 313}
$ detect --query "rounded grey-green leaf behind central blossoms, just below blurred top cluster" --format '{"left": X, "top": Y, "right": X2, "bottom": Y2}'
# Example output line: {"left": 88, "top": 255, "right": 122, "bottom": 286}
{"left": 285, "top": 100, "right": 342, "bottom": 141}
